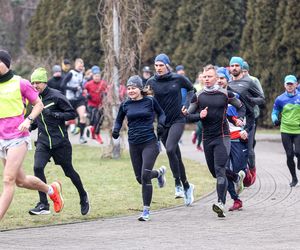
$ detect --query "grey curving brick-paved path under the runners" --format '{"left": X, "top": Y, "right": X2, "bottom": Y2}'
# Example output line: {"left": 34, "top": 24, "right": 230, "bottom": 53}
{"left": 0, "top": 132, "right": 300, "bottom": 250}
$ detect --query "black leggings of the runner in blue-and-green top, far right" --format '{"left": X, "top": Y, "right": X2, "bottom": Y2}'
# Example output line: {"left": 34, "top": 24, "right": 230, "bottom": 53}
{"left": 281, "top": 133, "right": 300, "bottom": 179}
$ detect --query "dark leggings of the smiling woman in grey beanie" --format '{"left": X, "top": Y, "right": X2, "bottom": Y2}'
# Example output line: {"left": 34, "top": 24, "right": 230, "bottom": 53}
{"left": 129, "top": 140, "right": 159, "bottom": 207}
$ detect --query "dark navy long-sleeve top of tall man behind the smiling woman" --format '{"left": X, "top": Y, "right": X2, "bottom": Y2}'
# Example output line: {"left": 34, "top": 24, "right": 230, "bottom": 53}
{"left": 146, "top": 72, "right": 194, "bottom": 126}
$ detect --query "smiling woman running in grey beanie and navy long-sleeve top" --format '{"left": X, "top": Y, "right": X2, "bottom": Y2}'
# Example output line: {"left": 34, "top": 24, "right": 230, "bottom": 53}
{"left": 112, "top": 75, "right": 166, "bottom": 221}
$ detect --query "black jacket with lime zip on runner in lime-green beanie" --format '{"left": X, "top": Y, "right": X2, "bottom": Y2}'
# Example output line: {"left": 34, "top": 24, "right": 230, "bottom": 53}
{"left": 30, "top": 86, "right": 76, "bottom": 149}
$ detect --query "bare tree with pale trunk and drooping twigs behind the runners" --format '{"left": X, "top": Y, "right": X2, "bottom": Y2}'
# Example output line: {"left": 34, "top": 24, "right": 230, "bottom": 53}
{"left": 98, "top": 0, "right": 144, "bottom": 158}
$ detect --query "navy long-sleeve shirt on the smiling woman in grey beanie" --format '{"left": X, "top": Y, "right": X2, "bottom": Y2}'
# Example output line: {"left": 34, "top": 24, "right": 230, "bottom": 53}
{"left": 114, "top": 96, "right": 166, "bottom": 144}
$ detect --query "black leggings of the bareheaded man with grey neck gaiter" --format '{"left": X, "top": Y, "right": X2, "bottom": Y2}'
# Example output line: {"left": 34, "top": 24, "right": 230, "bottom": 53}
{"left": 203, "top": 137, "right": 230, "bottom": 204}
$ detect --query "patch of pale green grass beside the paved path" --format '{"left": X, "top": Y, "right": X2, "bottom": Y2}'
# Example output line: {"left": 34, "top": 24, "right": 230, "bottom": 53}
{"left": 0, "top": 145, "right": 215, "bottom": 230}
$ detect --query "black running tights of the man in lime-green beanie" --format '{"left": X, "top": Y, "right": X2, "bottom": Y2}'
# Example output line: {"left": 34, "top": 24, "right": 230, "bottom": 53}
{"left": 34, "top": 141, "right": 86, "bottom": 205}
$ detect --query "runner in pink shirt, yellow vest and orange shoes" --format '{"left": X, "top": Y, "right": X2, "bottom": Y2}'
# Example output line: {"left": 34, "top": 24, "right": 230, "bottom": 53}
{"left": 0, "top": 50, "right": 64, "bottom": 220}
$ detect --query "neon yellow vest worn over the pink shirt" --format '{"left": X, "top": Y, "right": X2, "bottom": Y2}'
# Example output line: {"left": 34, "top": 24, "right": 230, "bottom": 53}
{"left": 0, "top": 76, "right": 24, "bottom": 118}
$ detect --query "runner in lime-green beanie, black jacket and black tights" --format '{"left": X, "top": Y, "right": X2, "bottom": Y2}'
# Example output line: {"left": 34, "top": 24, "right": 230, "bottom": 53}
{"left": 29, "top": 68, "right": 90, "bottom": 215}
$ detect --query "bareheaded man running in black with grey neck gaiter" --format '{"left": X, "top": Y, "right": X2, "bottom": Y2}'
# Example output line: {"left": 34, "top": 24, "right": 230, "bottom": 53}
{"left": 188, "top": 65, "right": 245, "bottom": 217}
